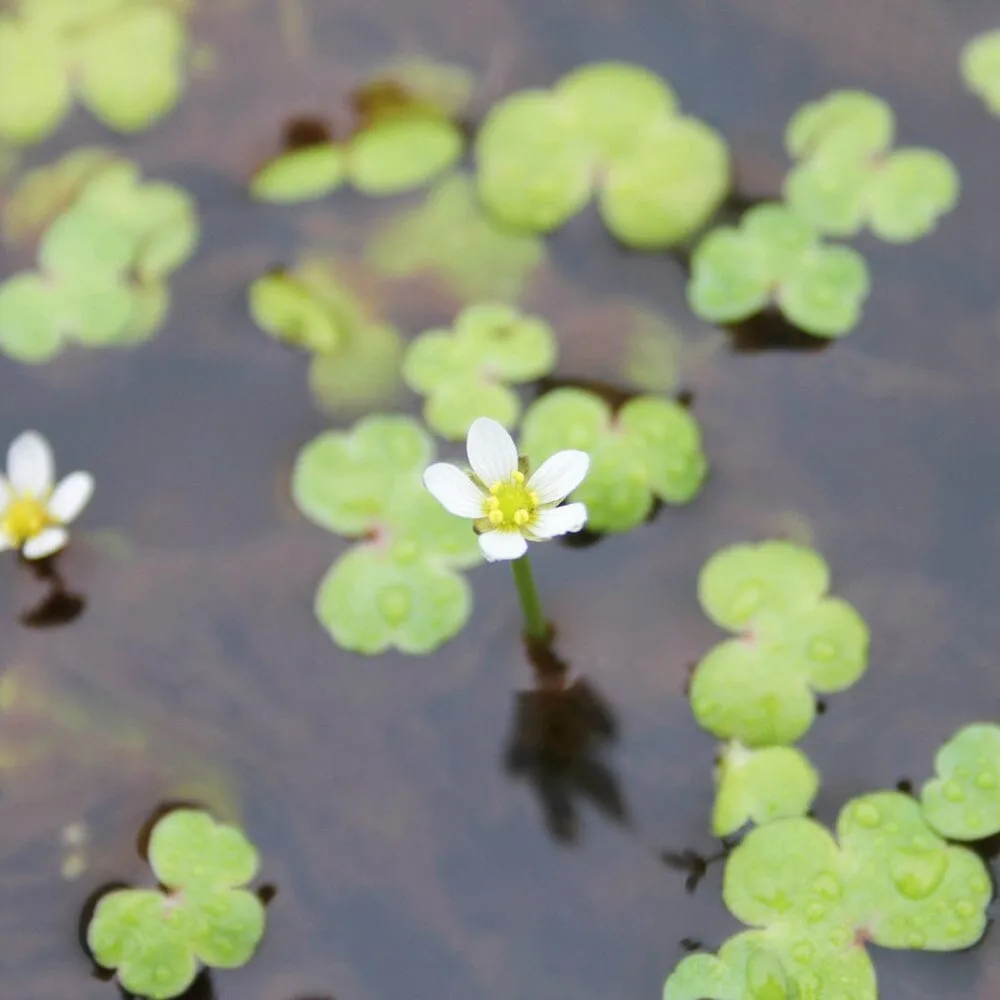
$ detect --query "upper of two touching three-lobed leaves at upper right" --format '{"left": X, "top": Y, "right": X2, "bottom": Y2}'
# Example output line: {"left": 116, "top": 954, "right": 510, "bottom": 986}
{"left": 784, "top": 90, "right": 959, "bottom": 243}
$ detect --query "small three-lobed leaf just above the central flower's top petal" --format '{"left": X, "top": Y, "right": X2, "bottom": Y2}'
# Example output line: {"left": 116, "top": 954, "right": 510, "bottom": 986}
{"left": 403, "top": 302, "right": 558, "bottom": 441}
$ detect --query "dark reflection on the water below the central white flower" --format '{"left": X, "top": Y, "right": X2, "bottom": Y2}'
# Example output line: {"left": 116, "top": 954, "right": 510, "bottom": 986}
{"left": 504, "top": 641, "right": 630, "bottom": 844}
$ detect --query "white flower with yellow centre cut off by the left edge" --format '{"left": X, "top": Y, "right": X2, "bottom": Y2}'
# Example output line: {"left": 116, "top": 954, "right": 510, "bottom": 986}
{"left": 0, "top": 431, "right": 94, "bottom": 559}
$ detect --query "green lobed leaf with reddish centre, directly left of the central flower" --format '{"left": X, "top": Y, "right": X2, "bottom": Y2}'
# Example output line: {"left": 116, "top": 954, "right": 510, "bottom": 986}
{"left": 292, "top": 415, "right": 482, "bottom": 654}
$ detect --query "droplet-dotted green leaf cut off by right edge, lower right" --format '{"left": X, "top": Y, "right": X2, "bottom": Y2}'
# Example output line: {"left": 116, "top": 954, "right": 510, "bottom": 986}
{"left": 920, "top": 722, "right": 1000, "bottom": 840}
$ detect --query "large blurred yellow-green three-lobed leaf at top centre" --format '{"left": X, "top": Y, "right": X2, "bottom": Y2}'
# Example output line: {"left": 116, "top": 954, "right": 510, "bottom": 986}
{"left": 475, "top": 62, "right": 729, "bottom": 249}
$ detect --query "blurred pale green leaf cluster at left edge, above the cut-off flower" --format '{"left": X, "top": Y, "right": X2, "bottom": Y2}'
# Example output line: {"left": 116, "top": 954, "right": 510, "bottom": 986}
{"left": 0, "top": 150, "right": 199, "bottom": 364}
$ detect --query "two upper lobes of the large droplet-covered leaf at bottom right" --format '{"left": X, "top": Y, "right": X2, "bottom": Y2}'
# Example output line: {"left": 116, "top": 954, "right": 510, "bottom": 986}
{"left": 723, "top": 792, "right": 991, "bottom": 951}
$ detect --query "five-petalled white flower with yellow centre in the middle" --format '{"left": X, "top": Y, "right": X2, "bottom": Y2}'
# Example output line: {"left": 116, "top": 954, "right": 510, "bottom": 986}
{"left": 424, "top": 417, "right": 590, "bottom": 562}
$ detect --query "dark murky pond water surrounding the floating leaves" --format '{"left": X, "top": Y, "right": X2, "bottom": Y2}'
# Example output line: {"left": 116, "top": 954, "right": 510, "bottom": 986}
{"left": 0, "top": 0, "right": 1000, "bottom": 1000}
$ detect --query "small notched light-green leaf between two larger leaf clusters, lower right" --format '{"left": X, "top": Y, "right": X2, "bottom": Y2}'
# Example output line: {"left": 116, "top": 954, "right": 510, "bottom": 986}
{"left": 712, "top": 742, "right": 819, "bottom": 837}
